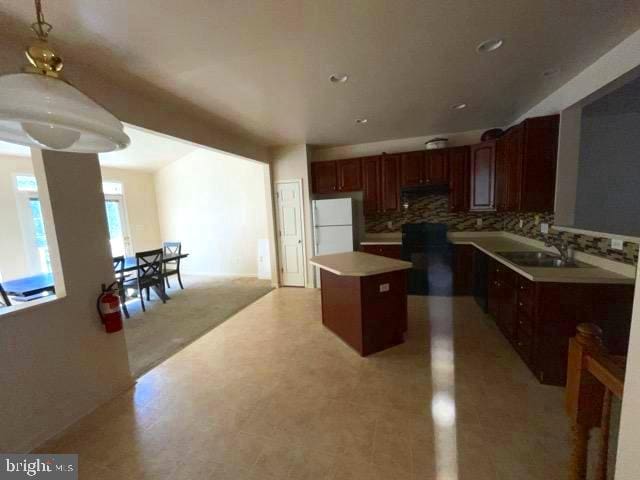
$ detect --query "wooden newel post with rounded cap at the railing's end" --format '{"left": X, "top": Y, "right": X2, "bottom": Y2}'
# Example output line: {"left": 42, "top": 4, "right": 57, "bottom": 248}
{"left": 566, "top": 323, "right": 604, "bottom": 480}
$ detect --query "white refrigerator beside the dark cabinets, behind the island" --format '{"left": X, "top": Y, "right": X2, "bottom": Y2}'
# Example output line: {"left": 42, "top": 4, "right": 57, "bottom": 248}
{"left": 312, "top": 198, "right": 354, "bottom": 288}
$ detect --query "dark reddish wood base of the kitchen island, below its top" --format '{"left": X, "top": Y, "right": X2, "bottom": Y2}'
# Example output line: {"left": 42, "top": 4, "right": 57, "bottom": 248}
{"left": 321, "top": 269, "right": 407, "bottom": 357}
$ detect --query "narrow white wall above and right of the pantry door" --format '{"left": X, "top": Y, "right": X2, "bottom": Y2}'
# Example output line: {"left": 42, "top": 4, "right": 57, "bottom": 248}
{"left": 271, "top": 145, "right": 314, "bottom": 288}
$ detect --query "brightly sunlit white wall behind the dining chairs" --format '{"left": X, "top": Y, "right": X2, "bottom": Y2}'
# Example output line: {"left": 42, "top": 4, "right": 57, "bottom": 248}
{"left": 155, "top": 149, "right": 268, "bottom": 275}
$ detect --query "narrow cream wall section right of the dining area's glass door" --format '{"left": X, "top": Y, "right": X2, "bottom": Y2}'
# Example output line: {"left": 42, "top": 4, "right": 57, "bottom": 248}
{"left": 101, "top": 167, "right": 162, "bottom": 252}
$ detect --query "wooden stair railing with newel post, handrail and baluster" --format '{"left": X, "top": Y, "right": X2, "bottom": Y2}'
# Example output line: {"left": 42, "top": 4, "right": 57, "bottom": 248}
{"left": 566, "top": 323, "right": 626, "bottom": 480}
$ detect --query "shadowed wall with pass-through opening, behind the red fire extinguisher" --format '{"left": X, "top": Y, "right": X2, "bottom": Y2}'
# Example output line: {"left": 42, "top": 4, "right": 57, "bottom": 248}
{"left": 0, "top": 152, "right": 132, "bottom": 452}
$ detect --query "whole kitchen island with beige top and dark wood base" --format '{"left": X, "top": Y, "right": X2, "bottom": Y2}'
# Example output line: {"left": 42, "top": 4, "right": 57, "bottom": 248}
{"left": 310, "top": 252, "right": 411, "bottom": 357}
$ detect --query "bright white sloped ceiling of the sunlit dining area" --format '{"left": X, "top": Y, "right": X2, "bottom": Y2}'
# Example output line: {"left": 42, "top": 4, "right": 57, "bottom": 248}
{"left": 0, "top": 125, "right": 199, "bottom": 172}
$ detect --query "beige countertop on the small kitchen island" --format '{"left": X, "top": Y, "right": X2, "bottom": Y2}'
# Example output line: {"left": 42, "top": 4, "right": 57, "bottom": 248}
{"left": 309, "top": 252, "right": 412, "bottom": 277}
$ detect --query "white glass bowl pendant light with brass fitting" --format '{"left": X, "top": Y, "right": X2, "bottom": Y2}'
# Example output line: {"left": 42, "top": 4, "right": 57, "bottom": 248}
{"left": 0, "top": 0, "right": 130, "bottom": 153}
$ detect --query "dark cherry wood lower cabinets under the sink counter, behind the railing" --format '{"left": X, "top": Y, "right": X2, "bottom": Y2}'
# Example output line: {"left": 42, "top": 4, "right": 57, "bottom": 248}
{"left": 488, "top": 259, "right": 633, "bottom": 385}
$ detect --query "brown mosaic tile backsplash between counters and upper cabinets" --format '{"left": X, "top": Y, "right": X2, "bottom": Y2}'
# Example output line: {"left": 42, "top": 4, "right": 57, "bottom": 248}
{"left": 365, "top": 194, "right": 638, "bottom": 265}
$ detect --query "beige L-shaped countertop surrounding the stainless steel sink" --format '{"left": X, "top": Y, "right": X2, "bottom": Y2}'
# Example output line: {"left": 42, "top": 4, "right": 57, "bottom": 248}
{"left": 449, "top": 232, "right": 635, "bottom": 285}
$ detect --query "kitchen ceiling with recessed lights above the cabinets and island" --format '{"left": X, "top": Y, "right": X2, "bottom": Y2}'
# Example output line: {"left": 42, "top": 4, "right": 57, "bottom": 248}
{"left": 0, "top": 0, "right": 640, "bottom": 145}
